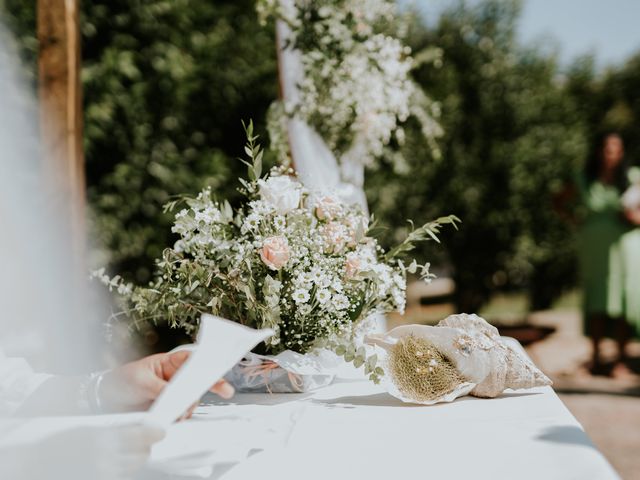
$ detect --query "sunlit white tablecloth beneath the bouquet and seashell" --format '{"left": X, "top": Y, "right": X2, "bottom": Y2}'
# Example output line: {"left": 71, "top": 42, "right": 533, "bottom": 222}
{"left": 0, "top": 380, "right": 618, "bottom": 480}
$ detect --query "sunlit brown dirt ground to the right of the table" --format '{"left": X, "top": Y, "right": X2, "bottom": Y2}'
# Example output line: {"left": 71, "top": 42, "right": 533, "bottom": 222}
{"left": 527, "top": 311, "right": 640, "bottom": 480}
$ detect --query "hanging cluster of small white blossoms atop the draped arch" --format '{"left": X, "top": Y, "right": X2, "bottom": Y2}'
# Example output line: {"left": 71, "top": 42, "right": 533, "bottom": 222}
{"left": 258, "top": 0, "right": 442, "bottom": 169}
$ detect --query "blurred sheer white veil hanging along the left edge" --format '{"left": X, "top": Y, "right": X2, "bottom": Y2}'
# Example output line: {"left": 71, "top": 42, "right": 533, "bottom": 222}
{"left": 0, "top": 25, "right": 100, "bottom": 373}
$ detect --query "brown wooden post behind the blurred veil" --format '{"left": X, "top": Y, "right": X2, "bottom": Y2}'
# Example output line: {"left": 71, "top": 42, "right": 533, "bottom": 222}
{"left": 37, "top": 0, "right": 85, "bottom": 258}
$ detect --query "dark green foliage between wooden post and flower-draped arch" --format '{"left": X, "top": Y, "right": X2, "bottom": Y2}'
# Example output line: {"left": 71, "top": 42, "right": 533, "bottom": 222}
{"left": 3, "top": 0, "right": 277, "bottom": 282}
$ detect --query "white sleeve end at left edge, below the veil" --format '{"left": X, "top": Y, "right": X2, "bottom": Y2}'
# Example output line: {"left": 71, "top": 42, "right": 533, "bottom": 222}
{"left": 0, "top": 350, "right": 51, "bottom": 417}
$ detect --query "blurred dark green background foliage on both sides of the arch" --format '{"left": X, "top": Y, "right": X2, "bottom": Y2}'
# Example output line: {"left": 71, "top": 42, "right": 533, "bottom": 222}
{"left": 6, "top": 0, "right": 640, "bottom": 318}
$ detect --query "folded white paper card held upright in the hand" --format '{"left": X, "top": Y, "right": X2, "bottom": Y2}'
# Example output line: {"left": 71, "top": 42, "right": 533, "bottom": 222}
{"left": 145, "top": 314, "right": 273, "bottom": 427}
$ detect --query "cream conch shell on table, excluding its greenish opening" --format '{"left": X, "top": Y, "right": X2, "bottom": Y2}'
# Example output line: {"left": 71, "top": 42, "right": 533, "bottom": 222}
{"left": 365, "top": 314, "right": 551, "bottom": 404}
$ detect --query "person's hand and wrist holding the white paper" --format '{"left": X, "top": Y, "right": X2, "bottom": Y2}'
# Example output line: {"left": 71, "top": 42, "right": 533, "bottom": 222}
{"left": 98, "top": 350, "right": 234, "bottom": 418}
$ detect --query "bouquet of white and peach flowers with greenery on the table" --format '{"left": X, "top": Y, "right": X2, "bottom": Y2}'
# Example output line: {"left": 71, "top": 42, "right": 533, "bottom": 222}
{"left": 98, "top": 124, "right": 458, "bottom": 381}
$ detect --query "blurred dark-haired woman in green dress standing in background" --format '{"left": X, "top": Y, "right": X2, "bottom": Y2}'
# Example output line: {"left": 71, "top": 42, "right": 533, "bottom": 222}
{"left": 578, "top": 134, "right": 629, "bottom": 374}
